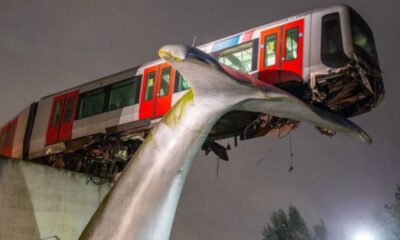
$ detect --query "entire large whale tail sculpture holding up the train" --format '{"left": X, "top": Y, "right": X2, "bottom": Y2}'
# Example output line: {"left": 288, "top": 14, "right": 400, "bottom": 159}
{"left": 80, "top": 45, "right": 372, "bottom": 240}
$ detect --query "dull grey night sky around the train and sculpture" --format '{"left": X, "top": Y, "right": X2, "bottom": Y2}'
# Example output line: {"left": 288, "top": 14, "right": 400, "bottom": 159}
{"left": 0, "top": 0, "right": 400, "bottom": 240}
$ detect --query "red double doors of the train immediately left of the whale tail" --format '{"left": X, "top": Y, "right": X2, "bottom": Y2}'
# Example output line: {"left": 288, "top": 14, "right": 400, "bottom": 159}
{"left": 139, "top": 63, "right": 173, "bottom": 119}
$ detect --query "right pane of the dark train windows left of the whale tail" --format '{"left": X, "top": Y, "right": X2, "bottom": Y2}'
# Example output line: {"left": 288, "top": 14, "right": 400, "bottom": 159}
{"left": 108, "top": 78, "right": 140, "bottom": 111}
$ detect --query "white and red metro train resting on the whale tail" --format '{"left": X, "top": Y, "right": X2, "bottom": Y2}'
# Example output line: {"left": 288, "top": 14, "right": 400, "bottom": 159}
{"left": 0, "top": 5, "right": 384, "bottom": 177}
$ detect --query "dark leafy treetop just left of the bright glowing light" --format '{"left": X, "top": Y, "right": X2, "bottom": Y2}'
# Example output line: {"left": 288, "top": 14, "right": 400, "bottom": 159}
{"left": 262, "top": 206, "right": 328, "bottom": 240}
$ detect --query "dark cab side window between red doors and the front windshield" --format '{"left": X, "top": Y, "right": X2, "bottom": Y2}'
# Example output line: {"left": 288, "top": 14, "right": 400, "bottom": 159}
{"left": 321, "top": 13, "right": 346, "bottom": 67}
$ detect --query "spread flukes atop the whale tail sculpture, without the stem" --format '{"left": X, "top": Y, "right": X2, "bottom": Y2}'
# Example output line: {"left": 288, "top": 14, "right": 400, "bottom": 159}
{"left": 159, "top": 45, "right": 372, "bottom": 144}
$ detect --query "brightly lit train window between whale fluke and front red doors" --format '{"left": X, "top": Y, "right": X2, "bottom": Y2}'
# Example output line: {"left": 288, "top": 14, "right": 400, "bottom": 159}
{"left": 218, "top": 41, "right": 253, "bottom": 73}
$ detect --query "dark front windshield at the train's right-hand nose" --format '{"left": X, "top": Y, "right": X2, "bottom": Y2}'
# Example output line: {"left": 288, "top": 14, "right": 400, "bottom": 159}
{"left": 351, "top": 11, "right": 378, "bottom": 66}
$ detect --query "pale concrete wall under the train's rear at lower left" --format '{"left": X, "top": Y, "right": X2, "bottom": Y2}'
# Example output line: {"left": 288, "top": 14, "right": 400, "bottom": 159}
{"left": 0, "top": 157, "right": 112, "bottom": 240}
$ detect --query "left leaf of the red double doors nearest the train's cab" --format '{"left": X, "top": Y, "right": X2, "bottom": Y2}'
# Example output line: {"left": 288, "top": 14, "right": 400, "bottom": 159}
{"left": 258, "top": 27, "right": 281, "bottom": 84}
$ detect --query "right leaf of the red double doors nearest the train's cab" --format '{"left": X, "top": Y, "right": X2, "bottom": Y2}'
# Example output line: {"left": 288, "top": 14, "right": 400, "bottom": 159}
{"left": 280, "top": 19, "right": 304, "bottom": 82}
